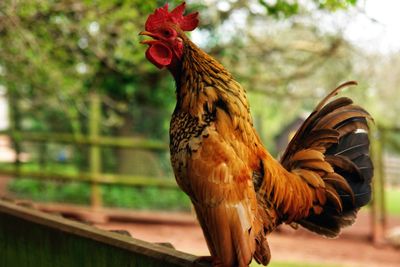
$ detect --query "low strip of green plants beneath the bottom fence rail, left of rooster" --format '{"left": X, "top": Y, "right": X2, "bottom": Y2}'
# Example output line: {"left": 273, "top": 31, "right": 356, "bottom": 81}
{"left": 9, "top": 178, "right": 191, "bottom": 211}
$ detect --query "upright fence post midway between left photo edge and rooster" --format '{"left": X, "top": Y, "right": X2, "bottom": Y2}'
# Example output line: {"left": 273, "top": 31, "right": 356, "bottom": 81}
{"left": 89, "top": 91, "right": 102, "bottom": 209}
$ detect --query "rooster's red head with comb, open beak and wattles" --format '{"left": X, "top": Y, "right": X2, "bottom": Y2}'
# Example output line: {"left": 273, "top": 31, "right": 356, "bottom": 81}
{"left": 140, "top": 2, "right": 199, "bottom": 69}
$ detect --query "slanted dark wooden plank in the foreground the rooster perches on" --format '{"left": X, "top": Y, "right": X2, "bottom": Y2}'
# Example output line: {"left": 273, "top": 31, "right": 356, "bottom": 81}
{"left": 0, "top": 201, "right": 207, "bottom": 267}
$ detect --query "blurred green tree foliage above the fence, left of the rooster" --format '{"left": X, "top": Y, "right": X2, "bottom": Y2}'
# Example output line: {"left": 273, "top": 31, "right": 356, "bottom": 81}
{"left": 0, "top": 0, "right": 178, "bottom": 137}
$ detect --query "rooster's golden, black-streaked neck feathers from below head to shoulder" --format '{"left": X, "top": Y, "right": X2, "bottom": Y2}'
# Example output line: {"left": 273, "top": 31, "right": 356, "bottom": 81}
{"left": 171, "top": 41, "right": 262, "bottom": 153}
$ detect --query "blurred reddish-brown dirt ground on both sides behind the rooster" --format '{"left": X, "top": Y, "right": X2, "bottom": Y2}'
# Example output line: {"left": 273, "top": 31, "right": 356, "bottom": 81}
{"left": 97, "top": 213, "right": 400, "bottom": 267}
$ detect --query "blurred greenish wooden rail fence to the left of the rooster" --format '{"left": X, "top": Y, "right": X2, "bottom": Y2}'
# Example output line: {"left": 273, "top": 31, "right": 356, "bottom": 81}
{"left": 0, "top": 93, "right": 177, "bottom": 208}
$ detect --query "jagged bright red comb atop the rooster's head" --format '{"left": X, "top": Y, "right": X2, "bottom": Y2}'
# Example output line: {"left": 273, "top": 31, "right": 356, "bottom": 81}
{"left": 145, "top": 2, "right": 199, "bottom": 32}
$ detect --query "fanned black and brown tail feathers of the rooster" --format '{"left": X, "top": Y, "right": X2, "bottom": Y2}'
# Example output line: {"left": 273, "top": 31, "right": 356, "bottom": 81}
{"left": 281, "top": 82, "right": 373, "bottom": 237}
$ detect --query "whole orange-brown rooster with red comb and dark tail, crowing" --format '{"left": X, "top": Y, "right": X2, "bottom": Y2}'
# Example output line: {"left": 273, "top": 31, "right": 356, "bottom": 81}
{"left": 140, "top": 3, "right": 373, "bottom": 267}
